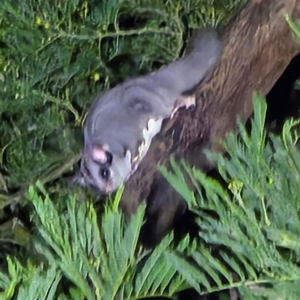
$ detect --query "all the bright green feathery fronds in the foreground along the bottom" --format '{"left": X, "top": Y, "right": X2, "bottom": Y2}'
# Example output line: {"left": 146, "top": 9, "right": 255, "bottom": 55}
{"left": 0, "top": 90, "right": 300, "bottom": 299}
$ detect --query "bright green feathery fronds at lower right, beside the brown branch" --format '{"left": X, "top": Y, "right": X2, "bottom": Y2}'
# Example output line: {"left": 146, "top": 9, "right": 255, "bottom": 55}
{"left": 161, "top": 95, "right": 300, "bottom": 294}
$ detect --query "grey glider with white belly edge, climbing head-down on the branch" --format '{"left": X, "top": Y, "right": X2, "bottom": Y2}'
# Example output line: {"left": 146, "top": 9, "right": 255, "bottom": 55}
{"left": 77, "top": 28, "right": 222, "bottom": 194}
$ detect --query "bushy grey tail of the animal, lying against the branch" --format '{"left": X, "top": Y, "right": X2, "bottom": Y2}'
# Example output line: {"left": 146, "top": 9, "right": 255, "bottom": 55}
{"left": 153, "top": 28, "right": 223, "bottom": 94}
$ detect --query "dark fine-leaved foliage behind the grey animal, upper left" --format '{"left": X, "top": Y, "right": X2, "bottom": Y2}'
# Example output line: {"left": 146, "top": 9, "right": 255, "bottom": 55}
{"left": 0, "top": 0, "right": 245, "bottom": 193}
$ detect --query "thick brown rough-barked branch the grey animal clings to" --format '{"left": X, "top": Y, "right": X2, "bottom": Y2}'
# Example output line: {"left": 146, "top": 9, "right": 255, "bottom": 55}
{"left": 121, "top": 0, "right": 300, "bottom": 244}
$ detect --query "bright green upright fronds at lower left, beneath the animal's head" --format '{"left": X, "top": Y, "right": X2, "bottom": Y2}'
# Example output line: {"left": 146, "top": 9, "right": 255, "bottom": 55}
{"left": 0, "top": 183, "right": 192, "bottom": 300}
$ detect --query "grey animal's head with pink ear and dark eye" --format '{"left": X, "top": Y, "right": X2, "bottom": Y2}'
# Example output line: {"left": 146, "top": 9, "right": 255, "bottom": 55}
{"left": 80, "top": 144, "right": 132, "bottom": 194}
